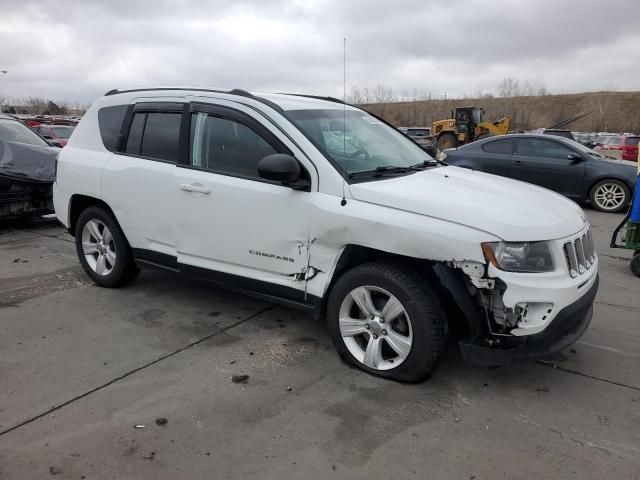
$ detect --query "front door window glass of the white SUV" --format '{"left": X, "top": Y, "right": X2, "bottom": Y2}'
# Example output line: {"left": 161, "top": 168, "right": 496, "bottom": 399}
{"left": 190, "top": 113, "right": 278, "bottom": 179}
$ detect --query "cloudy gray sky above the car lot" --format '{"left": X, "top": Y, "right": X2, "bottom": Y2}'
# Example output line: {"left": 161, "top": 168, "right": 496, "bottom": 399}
{"left": 0, "top": 0, "right": 640, "bottom": 102}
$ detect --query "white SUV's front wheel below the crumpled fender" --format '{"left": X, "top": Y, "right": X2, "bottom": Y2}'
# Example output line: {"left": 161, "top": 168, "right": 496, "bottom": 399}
{"left": 327, "top": 262, "right": 446, "bottom": 382}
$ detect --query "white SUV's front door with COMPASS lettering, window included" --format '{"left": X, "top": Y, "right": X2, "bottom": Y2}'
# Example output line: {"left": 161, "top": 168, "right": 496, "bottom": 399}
{"left": 174, "top": 103, "right": 317, "bottom": 301}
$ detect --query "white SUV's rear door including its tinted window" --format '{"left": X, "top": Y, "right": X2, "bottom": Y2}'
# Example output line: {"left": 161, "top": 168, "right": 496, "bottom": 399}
{"left": 102, "top": 101, "right": 184, "bottom": 263}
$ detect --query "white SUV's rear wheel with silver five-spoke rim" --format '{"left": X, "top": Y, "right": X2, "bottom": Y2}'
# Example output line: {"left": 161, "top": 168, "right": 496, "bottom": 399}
{"left": 76, "top": 207, "right": 139, "bottom": 288}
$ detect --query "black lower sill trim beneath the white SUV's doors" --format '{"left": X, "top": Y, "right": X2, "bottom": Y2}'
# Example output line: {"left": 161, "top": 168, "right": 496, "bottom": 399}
{"left": 133, "top": 248, "right": 322, "bottom": 311}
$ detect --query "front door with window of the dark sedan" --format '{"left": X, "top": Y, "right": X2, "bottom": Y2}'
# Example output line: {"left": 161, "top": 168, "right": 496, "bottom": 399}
{"left": 511, "top": 137, "right": 585, "bottom": 197}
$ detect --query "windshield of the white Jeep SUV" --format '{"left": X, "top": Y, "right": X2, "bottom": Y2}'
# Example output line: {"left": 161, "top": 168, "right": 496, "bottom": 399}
{"left": 287, "top": 109, "right": 432, "bottom": 174}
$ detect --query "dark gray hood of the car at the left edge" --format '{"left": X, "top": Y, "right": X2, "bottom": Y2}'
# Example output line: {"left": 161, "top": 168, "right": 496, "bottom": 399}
{"left": 0, "top": 140, "right": 60, "bottom": 183}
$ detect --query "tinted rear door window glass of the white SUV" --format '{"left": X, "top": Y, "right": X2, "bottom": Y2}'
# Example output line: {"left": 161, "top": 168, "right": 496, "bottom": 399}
{"left": 125, "top": 112, "right": 182, "bottom": 162}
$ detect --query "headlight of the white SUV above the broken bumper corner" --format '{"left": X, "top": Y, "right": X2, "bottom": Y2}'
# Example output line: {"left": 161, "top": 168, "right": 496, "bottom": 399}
{"left": 482, "top": 242, "right": 556, "bottom": 273}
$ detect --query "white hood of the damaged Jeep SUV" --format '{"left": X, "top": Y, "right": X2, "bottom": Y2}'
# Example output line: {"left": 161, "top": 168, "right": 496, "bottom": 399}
{"left": 350, "top": 167, "right": 586, "bottom": 241}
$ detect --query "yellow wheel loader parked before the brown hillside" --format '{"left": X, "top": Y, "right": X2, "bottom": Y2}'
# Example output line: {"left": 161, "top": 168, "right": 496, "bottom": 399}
{"left": 431, "top": 107, "right": 511, "bottom": 151}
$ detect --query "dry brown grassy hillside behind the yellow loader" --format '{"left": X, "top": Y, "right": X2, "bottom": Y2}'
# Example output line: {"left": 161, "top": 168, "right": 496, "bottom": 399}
{"left": 363, "top": 92, "right": 640, "bottom": 133}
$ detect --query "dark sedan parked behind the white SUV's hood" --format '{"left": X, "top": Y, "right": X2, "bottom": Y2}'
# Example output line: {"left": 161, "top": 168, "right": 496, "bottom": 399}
{"left": 443, "top": 134, "right": 637, "bottom": 212}
